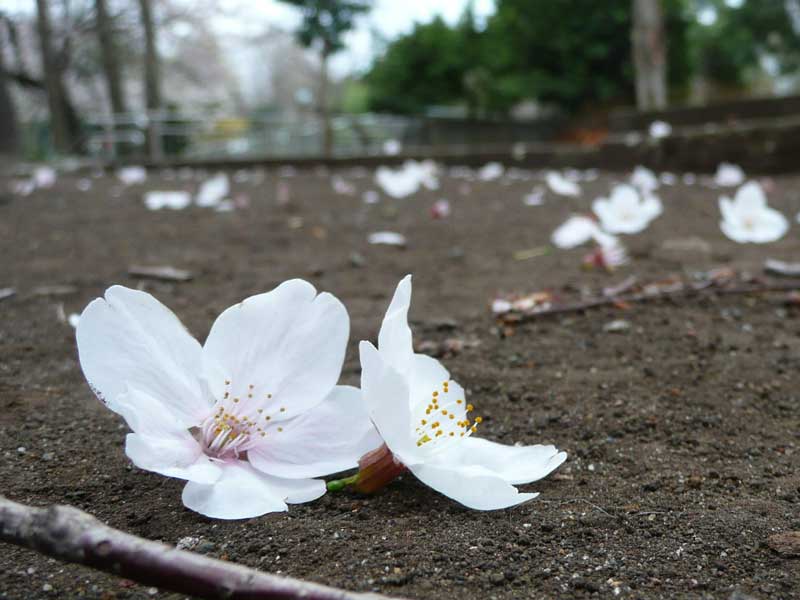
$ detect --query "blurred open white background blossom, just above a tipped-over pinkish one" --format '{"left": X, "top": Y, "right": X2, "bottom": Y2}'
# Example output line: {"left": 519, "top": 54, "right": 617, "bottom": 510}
{"left": 592, "top": 183, "right": 662, "bottom": 234}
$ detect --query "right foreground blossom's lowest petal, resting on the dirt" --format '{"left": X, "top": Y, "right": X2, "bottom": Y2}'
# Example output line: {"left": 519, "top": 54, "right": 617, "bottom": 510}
{"left": 409, "top": 464, "right": 538, "bottom": 510}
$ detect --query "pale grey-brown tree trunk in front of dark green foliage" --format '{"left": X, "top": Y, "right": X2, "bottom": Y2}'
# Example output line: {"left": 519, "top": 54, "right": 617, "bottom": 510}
{"left": 631, "top": 0, "right": 667, "bottom": 110}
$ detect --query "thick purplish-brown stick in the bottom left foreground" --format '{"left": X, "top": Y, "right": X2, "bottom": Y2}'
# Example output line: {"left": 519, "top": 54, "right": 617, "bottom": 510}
{"left": 0, "top": 496, "right": 400, "bottom": 600}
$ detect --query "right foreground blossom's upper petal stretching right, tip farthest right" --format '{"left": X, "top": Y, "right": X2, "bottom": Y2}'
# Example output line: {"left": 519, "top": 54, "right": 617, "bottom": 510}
{"left": 437, "top": 436, "right": 567, "bottom": 484}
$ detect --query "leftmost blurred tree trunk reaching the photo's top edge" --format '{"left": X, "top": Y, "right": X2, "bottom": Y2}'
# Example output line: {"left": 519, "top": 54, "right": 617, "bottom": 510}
{"left": 36, "top": 0, "right": 72, "bottom": 153}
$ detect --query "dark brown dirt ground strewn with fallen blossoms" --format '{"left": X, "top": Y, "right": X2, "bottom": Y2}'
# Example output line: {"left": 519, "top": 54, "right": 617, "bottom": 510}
{"left": 0, "top": 164, "right": 800, "bottom": 600}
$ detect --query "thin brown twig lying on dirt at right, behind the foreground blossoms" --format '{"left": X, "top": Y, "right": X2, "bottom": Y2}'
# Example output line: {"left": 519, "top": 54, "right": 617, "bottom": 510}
{"left": 500, "top": 280, "right": 800, "bottom": 325}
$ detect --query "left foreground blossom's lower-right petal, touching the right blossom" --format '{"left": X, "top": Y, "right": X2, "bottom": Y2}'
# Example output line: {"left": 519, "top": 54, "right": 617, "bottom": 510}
{"left": 247, "top": 385, "right": 383, "bottom": 478}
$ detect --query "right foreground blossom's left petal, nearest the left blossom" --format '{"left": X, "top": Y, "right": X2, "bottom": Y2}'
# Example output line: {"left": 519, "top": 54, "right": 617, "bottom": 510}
{"left": 359, "top": 342, "right": 417, "bottom": 464}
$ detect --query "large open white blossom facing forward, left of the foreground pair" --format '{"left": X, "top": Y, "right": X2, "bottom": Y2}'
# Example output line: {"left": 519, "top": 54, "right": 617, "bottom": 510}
{"left": 76, "top": 279, "right": 380, "bottom": 519}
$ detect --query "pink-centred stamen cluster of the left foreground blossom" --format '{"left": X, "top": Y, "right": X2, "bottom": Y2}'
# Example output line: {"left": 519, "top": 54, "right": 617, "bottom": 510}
{"left": 198, "top": 380, "right": 286, "bottom": 460}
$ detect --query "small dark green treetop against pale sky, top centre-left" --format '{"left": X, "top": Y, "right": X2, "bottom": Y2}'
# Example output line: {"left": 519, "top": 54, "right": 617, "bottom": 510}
{"left": 280, "top": 0, "right": 371, "bottom": 56}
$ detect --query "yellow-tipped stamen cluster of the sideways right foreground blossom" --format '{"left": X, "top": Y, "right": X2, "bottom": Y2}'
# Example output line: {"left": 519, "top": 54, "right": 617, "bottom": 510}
{"left": 414, "top": 381, "right": 483, "bottom": 448}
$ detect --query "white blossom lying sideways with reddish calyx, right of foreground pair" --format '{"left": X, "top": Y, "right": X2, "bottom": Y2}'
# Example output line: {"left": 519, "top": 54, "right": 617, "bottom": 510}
{"left": 328, "top": 276, "right": 566, "bottom": 510}
